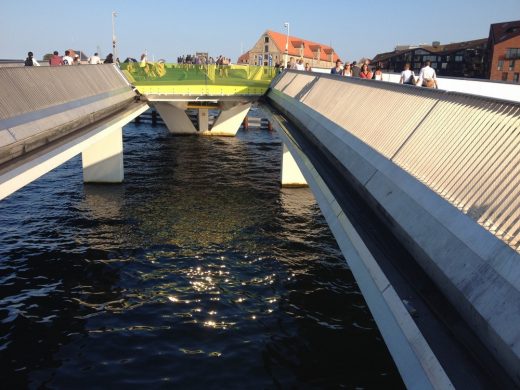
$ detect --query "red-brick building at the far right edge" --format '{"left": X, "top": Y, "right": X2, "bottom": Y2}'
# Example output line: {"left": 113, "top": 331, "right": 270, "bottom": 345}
{"left": 486, "top": 20, "right": 520, "bottom": 83}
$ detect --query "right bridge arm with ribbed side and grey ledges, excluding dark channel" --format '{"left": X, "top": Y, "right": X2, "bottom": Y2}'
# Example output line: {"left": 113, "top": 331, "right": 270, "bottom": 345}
{"left": 267, "top": 71, "right": 520, "bottom": 387}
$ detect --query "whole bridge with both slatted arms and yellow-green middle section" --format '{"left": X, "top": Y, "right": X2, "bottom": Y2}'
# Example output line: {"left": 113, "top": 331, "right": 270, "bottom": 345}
{"left": 0, "top": 64, "right": 520, "bottom": 388}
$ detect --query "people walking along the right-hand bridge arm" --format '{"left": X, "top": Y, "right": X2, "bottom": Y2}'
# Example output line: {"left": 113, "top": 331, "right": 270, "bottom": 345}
{"left": 330, "top": 59, "right": 437, "bottom": 88}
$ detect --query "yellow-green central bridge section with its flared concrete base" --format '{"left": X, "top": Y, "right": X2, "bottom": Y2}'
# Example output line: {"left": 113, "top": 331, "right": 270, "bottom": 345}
{"left": 121, "top": 62, "right": 276, "bottom": 136}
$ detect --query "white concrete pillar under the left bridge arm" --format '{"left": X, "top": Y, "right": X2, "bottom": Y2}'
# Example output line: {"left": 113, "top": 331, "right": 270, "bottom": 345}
{"left": 81, "top": 127, "right": 124, "bottom": 183}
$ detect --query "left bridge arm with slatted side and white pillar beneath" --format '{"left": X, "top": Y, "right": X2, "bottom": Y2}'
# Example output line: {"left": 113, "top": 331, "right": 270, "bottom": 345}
{"left": 0, "top": 65, "right": 148, "bottom": 199}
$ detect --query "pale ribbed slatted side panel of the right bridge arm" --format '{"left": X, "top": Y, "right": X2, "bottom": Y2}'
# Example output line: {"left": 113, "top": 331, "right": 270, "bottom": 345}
{"left": 274, "top": 72, "right": 520, "bottom": 252}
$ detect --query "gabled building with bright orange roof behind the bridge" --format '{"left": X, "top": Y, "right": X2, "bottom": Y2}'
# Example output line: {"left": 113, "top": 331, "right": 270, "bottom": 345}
{"left": 237, "top": 30, "right": 339, "bottom": 68}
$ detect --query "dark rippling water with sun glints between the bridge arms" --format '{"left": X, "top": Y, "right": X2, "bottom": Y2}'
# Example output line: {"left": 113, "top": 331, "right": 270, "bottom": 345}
{"left": 0, "top": 111, "right": 403, "bottom": 389}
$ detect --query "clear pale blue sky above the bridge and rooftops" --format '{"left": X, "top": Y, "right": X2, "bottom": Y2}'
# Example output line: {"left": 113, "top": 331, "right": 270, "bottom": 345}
{"left": 0, "top": 0, "right": 520, "bottom": 61}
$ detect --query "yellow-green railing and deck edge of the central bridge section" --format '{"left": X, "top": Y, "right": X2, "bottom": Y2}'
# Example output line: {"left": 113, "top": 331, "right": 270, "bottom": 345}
{"left": 121, "top": 62, "right": 276, "bottom": 96}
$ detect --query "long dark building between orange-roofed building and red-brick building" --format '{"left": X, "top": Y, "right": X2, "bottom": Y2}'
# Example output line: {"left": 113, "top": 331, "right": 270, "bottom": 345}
{"left": 372, "top": 38, "right": 488, "bottom": 78}
